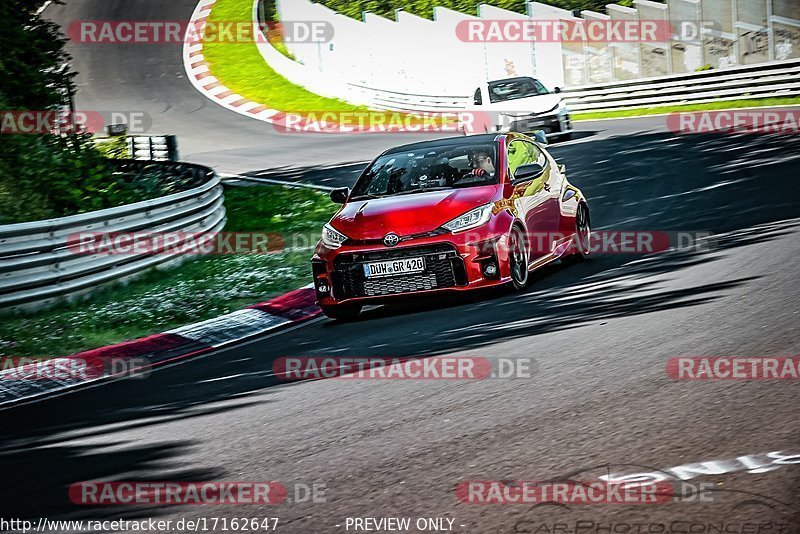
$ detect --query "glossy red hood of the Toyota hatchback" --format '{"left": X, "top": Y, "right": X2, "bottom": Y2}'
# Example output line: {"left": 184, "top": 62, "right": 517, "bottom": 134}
{"left": 331, "top": 185, "right": 500, "bottom": 240}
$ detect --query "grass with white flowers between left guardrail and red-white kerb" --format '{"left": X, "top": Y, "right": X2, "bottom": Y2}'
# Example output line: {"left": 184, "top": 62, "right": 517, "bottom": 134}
{"left": 0, "top": 186, "right": 336, "bottom": 357}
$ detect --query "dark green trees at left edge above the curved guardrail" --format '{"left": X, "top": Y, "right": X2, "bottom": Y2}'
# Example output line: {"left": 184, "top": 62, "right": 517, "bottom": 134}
{"left": 0, "top": 0, "right": 109, "bottom": 224}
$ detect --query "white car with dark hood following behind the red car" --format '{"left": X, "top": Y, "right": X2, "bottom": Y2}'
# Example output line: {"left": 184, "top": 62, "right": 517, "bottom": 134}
{"left": 473, "top": 76, "right": 572, "bottom": 139}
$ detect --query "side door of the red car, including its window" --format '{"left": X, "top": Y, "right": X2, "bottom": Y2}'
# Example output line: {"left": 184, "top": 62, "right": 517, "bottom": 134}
{"left": 507, "top": 139, "right": 560, "bottom": 260}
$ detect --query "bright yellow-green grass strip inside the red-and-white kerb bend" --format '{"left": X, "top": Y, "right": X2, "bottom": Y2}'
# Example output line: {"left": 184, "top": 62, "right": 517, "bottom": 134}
{"left": 203, "top": 0, "right": 367, "bottom": 112}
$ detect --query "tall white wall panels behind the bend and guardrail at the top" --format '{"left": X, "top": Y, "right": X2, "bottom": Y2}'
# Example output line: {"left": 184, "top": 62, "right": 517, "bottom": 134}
{"left": 264, "top": 0, "right": 800, "bottom": 109}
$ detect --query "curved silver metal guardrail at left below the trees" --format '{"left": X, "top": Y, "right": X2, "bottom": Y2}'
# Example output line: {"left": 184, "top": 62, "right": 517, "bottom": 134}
{"left": 0, "top": 160, "right": 225, "bottom": 313}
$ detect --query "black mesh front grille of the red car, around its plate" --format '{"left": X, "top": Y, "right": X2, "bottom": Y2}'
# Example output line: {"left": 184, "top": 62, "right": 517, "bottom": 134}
{"left": 332, "top": 243, "right": 467, "bottom": 298}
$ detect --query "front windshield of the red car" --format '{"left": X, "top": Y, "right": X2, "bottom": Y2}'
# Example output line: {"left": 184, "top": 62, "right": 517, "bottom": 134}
{"left": 350, "top": 143, "right": 497, "bottom": 200}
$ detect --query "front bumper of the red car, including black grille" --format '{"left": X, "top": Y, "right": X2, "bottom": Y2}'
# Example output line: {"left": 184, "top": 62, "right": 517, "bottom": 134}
{"left": 312, "top": 232, "right": 509, "bottom": 306}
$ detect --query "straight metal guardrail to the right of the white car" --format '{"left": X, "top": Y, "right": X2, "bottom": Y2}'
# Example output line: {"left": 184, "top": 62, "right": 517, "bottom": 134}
{"left": 561, "top": 59, "right": 800, "bottom": 111}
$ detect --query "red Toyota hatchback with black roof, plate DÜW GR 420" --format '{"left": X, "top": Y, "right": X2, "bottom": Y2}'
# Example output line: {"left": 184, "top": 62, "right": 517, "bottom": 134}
{"left": 311, "top": 133, "right": 591, "bottom": 320}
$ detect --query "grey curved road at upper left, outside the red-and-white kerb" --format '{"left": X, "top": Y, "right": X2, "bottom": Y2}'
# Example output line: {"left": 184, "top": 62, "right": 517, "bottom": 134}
{"left": 45, "top": 0, "right": 462, "bottom": 172}
